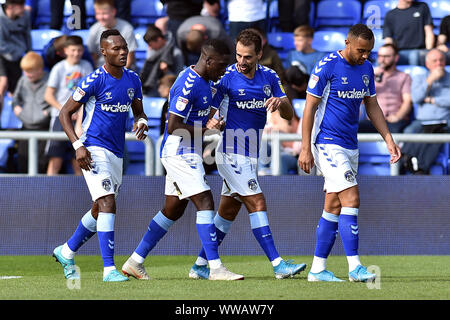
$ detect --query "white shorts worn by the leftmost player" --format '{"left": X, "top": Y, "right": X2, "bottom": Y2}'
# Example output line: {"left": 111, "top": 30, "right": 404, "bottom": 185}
{"left": 82, "top": 146, "right": 123, "bottom": 201}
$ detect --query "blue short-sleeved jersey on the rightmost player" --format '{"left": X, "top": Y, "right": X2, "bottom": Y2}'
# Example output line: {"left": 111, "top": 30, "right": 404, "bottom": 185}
{"left": 306, "top": 51, "right": 376, "bottom": 149}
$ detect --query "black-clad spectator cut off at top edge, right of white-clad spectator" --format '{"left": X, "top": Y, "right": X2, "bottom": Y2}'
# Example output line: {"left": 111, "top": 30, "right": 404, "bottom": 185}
{"left": 278, "top": 0, "right": 311, "bottom": 32}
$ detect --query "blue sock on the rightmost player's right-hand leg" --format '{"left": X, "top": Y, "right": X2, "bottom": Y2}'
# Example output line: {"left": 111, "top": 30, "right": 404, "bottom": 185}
{"left": 339, "top": 207, "right": 359, "bottom": 256}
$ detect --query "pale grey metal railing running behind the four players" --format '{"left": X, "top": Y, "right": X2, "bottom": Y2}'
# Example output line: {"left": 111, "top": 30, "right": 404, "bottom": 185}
{"left": 0, "top": 131, "right": 450, "bottom": 176}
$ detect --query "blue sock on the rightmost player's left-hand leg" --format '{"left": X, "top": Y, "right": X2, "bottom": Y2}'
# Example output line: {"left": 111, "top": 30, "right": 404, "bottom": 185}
{"left": 314, "top": 211, "right": 339, "bottom": 259}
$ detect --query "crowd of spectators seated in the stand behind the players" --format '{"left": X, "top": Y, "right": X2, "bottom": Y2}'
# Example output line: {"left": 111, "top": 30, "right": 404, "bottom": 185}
{"left": 0, "top": 0, "right": 450, "bottom": 175}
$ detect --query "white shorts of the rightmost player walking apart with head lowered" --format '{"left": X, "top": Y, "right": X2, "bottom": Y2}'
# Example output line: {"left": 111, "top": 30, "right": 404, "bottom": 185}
{"left": 312, "top": 144, "right": 359, "bottom": 193}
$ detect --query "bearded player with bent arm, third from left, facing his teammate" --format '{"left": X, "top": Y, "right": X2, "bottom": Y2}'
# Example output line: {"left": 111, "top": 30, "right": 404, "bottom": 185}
{"left": 189, "top": 29, "right": 306, "bottom": 279}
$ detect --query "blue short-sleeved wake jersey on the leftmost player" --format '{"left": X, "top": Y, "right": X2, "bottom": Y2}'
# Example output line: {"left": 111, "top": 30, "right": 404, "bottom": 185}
{"left": 72, "top": 67, "right": 142, "bottom": 158}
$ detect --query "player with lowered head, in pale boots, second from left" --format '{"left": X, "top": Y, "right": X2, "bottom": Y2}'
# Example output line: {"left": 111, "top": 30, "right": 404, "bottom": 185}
{"left": 122, "top": 40, "right": 244, "bottom": 280}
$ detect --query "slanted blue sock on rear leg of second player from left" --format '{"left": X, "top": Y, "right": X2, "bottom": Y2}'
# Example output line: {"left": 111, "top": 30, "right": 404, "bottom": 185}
{"left": 134, "top": 211, "right": 174, "bottom": 259}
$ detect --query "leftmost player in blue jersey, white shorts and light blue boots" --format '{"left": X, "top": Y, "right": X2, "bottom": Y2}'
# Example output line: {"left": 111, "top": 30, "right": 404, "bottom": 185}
{"left": 53, "top": 29, "right": 148, "bottom": 282}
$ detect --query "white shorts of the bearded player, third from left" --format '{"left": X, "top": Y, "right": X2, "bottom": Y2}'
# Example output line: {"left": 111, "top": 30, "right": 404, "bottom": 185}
{"left": 216, "top": 150, "right": 262, "bottom": 197}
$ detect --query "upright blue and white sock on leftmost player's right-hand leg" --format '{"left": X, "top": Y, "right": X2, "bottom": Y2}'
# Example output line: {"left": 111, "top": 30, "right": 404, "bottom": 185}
{"left": 97, "top": 212, "right": 116, "bottom": 267}
